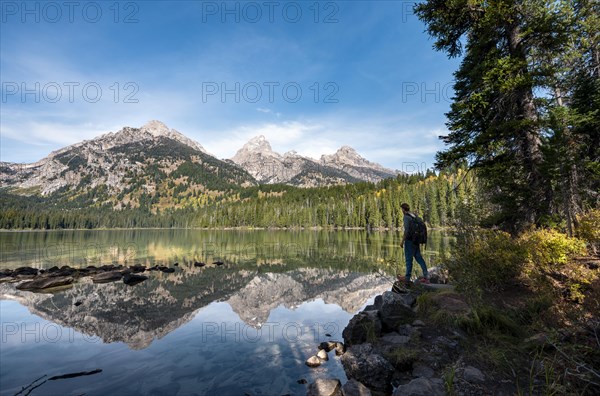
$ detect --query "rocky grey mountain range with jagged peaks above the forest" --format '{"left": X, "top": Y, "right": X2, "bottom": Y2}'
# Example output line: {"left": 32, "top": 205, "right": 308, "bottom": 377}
{"left": 0, "top": 121, "right": 399, "bottom": 209}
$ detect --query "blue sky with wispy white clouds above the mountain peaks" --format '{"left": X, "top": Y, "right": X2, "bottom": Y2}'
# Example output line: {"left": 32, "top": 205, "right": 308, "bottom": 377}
{"left": 0, "top": 0, "right": 458, "bottom": 171}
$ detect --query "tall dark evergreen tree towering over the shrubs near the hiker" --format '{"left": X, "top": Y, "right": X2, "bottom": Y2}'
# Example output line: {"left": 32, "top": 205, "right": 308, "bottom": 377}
{"left": 415, "top": 0, "right": 560, "bottom": 230}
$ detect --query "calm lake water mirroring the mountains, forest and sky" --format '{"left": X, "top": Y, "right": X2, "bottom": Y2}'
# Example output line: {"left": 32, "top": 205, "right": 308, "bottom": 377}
{"left": 0, "top": 230, "right": 451, "bottom": 395}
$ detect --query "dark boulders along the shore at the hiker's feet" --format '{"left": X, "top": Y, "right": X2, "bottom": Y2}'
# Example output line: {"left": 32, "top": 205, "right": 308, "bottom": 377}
{"left": 306, "top": 285, "right": 504, "bottom": 396}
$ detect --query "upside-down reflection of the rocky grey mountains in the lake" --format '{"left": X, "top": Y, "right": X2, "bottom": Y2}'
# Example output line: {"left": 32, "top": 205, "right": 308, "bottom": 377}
{"left": 0, "top": 267, "right": 389, "bottom": 349}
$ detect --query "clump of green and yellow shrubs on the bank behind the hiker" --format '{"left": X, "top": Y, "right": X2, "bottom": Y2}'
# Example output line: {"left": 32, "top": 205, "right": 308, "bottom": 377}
{"left": 446, "top": 226, "right": 596, "bottom": 301}
